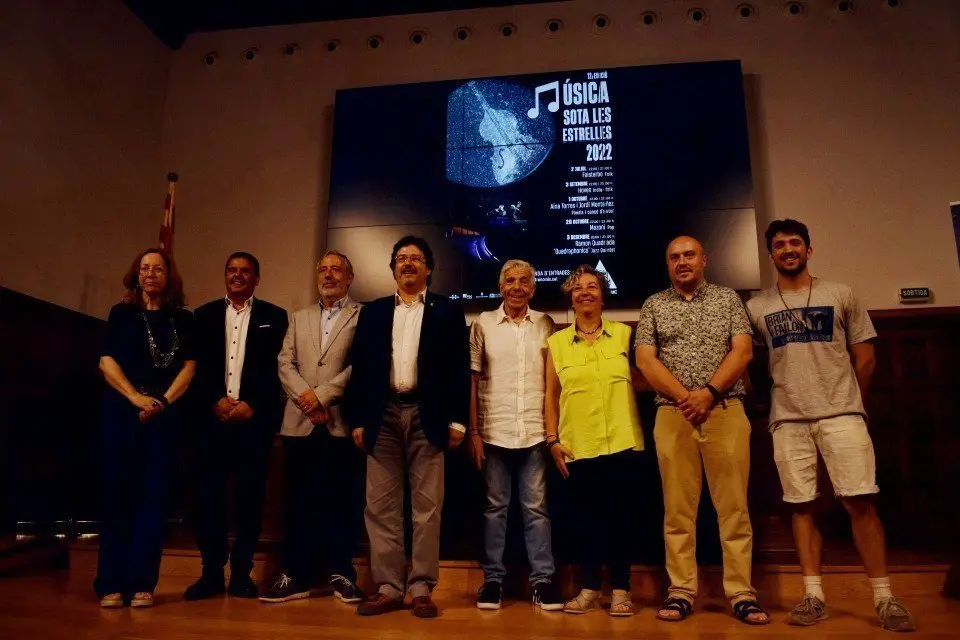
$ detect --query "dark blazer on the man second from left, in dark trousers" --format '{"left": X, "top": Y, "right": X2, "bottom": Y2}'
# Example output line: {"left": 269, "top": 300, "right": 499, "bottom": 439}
{"left": 193, "top": 298, "right": 288, "bottom": 429}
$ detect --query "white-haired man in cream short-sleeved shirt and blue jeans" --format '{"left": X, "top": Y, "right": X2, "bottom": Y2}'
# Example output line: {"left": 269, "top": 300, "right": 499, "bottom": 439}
{"left": 470, "top": 260, "right": 563, "bottom": 611}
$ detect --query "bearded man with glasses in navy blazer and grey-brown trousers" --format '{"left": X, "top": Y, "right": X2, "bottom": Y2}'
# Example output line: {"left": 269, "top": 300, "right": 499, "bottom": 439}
{"left": 346, "top": 236, "right": 470, "bottom": 618}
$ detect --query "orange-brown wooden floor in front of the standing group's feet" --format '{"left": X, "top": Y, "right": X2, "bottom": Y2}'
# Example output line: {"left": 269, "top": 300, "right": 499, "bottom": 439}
{"left": 0, "top": 571, "right": 960, "bottom": 640}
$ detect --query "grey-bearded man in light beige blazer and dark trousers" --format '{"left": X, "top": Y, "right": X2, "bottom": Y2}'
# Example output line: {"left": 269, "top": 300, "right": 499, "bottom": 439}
{"left": 260, "top": 251, "right": 364, "bottom": 603}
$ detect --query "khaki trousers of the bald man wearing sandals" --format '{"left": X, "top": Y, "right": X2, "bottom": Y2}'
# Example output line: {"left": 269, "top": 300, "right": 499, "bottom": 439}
{"left": 653, "top": 400, "right": 756, "bottom": 604}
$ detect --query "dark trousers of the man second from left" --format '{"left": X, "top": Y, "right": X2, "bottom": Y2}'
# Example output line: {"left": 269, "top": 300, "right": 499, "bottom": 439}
{"left": 195, "top": 419, "right": 273, "bottom": 576}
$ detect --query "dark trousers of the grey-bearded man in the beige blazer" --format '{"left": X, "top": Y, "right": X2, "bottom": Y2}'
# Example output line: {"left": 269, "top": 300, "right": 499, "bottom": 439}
{"left": 283, "top": 425, "right": 365, "bottom": 587}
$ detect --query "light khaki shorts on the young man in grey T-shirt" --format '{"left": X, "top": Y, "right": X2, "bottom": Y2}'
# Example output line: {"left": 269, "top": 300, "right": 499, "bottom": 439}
{"left": 773, "top": 415, "right": 880, "bottom": 503}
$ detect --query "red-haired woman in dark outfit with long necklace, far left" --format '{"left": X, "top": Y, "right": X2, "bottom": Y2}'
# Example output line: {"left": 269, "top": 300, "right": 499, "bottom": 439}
{"left": 94, "top": 249, "right": 196, "bottom": 607}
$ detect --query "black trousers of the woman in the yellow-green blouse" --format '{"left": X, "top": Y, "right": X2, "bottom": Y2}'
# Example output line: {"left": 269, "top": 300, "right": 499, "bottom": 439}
{"left": 567, "top": 450, "right": 637, "bottom": 591}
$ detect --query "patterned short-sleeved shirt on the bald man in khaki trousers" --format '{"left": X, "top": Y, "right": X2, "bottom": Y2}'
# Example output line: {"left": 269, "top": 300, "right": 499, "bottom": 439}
{"left": 633, "top": 281, "right": 753, "bottom": 405}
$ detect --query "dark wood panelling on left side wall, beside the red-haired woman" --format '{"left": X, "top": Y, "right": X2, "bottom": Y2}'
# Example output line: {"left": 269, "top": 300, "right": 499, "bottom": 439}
{"left": 0, "top": 288, "right": 106, "bottom": 533}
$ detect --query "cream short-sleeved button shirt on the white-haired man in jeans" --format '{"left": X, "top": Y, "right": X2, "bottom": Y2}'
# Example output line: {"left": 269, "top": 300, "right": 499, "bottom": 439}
{"left": 470, "top": 305, "right": 556, "bottom": 449}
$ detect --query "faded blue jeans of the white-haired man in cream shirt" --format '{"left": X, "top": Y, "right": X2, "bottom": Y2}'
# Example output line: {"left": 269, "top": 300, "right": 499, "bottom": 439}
{"left": 480, "top": 444, "right": 554, "bottom": 584}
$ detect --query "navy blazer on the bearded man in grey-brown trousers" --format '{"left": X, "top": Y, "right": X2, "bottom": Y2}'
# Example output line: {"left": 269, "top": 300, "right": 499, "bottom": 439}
{"left": 344, "top": 291, "right": 470, "bottom": 453}
